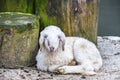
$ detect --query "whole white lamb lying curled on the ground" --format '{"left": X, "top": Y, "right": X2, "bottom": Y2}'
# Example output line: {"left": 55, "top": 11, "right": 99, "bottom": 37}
{"left": 36, "top": 26, "right": 102, "bottom": 75}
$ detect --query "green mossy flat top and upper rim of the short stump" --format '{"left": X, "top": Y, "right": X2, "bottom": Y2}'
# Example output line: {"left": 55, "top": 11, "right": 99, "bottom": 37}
{"left": 0, "top": 12, "right": 39, "bottom": 32}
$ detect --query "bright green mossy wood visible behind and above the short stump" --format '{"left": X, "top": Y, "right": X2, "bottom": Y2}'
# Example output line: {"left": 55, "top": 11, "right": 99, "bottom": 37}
{"left": 0, "top": 0, "right": 35, "bottom": 13}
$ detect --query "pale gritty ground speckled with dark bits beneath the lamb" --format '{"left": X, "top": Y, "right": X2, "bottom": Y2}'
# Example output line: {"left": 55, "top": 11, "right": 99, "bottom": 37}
{"left": 0, "top": 37, "right": 120, "bottom": 80}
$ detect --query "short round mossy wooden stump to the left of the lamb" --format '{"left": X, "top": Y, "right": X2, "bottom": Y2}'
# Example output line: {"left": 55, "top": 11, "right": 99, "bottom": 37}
{"left": 0, "top": 12, "right": 39, "bottom": 68}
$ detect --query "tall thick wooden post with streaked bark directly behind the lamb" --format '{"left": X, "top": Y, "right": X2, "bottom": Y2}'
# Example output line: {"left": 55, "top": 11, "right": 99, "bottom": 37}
{"left": 36, "top": 0, "right": 99, "bottom": 43}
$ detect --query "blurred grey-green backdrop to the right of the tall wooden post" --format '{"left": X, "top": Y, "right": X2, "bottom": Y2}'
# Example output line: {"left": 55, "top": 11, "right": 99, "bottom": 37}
{"left": 98, "top": 0, "right": 120, "bottom": 36}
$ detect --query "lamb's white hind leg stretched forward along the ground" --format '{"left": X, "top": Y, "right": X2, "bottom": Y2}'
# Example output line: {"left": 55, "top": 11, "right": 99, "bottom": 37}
{"left": 56, "top": 65, "right": 96, "bottom": 75}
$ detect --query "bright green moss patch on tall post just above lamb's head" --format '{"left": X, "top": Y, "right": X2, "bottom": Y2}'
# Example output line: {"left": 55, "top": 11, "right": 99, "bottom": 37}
{"left": 36, "top": 0, "right": 57, "bottom": 30}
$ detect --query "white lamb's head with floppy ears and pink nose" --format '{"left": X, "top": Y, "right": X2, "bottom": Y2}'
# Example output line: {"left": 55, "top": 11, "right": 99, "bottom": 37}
{"left": 39, "top": 26, "right": 65, "bottom": 52}
